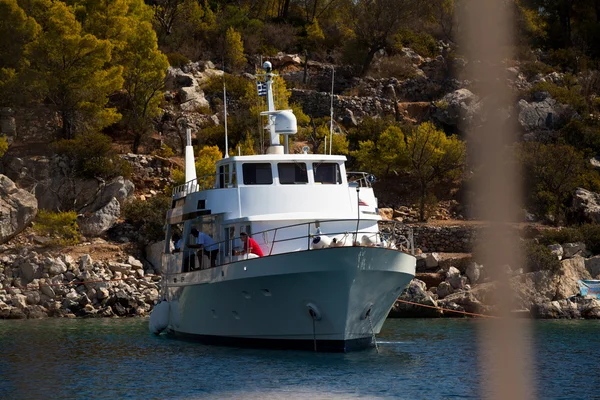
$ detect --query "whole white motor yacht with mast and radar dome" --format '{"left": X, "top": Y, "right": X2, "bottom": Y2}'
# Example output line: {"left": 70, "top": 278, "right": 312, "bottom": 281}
{"left": 150, "top": 62, "right": 416, "bottom": 351}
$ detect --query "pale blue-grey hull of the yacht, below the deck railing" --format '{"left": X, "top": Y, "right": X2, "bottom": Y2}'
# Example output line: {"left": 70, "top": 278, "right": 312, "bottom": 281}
{"left": 167, "top": 247, "right": 416, "bottom": 351}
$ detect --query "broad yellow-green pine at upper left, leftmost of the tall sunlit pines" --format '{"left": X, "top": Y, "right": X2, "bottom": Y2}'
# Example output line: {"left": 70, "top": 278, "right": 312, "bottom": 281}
{"left": 25, "top": 2, "right": 123, "bottom": 139}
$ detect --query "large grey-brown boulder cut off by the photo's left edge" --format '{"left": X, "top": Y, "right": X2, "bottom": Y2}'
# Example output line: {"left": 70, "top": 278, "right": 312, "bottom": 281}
{"left": 0, "top": 175, "right": 38, "bottom": 243}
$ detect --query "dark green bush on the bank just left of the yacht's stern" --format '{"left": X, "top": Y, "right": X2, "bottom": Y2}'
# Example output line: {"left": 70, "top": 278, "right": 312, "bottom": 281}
{"left": 123, "top": 195, "right": 171, "bottom": 241}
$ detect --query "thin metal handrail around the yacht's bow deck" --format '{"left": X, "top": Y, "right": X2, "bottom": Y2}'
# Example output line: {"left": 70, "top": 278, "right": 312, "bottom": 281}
{"left": 166, "top": 219, "right": 414, "bottom": 272}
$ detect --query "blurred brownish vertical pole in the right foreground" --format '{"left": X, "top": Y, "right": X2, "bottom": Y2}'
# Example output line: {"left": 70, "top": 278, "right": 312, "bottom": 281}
{"left": 457, "top": 0, "right": 534, "bottom": 400}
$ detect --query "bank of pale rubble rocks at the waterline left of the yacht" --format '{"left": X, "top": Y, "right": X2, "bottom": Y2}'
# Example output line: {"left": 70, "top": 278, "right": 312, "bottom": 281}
{"left": 0, "top": 239, "right": 161, "bottom": 319}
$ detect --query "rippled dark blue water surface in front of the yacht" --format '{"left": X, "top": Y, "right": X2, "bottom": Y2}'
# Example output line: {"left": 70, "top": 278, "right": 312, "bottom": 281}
{"left": 0, "top": 318, "right": 600, "bottom": 399}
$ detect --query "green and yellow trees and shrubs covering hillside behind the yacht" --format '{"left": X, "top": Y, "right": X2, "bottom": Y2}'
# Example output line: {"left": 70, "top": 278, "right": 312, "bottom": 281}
{"left": 0, "top": 0, "right": 600, "bottom": 224}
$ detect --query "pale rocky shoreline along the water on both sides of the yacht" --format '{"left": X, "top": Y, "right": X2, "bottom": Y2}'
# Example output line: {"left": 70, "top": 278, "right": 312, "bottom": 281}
{"left": 0, "top": 227, "right": 600, "bottom": 319}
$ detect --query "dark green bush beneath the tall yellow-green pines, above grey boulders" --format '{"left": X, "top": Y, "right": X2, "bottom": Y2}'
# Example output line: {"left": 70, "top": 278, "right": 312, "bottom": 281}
{"left": 53, "top": 133, "right": 131, "bottom": 179}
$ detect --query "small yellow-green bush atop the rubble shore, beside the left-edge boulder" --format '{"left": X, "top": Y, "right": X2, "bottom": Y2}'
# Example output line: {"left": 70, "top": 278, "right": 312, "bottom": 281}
{"left": 33, "top": 210, "right": 81, "bottom": 246}
